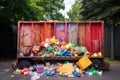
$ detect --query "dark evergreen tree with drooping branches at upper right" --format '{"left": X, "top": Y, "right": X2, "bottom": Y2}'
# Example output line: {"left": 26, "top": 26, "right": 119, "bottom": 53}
{"left": 80, "top": 0, "right": 120, "bottom": 26}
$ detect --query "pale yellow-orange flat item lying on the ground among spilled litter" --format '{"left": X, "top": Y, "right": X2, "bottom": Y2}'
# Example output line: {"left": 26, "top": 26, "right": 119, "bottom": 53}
{"left": 58, "top": 63, "right": 74, "bottom": 73}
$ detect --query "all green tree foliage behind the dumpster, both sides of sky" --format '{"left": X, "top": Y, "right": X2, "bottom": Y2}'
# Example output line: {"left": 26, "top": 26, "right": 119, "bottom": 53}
{"left": 0, "top": 0, "right": 120, "bottom": 26}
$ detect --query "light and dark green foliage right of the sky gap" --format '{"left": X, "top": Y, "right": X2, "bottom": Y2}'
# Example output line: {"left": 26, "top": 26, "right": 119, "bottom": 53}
{"left": 68, "top": 0, "right": 120, "bottom": 26}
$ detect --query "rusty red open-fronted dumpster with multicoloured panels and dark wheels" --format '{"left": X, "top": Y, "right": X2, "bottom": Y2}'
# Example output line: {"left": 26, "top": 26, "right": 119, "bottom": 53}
{"left": 17, "top": 21, "right": 104, "bottom": 68}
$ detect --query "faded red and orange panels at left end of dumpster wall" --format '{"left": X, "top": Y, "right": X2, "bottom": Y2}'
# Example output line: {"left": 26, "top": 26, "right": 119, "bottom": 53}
{"left": 18, "top": 21, "right": 54, "bottom": 52}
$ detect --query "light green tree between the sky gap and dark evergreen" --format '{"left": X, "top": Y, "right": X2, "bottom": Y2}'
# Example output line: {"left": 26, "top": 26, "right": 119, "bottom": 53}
{"left": 67, "top": 0, "right": 83, "bottom": 21}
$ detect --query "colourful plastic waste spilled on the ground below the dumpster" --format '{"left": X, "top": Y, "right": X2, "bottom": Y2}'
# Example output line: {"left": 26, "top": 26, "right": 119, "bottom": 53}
{"left": 14, "top": 61, "right": 103, "bottom": 80}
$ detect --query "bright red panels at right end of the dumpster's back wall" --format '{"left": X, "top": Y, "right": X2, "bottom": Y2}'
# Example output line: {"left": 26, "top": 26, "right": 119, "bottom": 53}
{"left": 85, "top": 21, "right": 104, "bottom": 53}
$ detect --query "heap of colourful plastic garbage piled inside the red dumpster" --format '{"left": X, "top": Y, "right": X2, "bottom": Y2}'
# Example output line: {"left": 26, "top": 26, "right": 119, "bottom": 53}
{"left": 19, "top": 37, "right": 103, "bottom": 57}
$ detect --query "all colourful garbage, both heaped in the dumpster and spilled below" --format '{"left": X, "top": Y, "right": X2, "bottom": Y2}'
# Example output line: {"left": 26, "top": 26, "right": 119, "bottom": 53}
{"left": 15, "top": 37, "right": 103, "bottom": 80}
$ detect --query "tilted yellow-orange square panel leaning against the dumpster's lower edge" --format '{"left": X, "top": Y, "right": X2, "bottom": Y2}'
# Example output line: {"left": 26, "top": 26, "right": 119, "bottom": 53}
{"left": 76, "top": 56, "right": 92, "bottom": 70}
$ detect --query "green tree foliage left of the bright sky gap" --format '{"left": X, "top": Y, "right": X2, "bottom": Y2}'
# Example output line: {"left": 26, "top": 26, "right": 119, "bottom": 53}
{"left": 0, "top": 0, "right": 64, "bottom": 24}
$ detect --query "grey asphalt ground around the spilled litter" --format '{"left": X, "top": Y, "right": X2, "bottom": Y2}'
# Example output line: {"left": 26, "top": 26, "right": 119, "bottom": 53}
{"left": 0, "top": 61, "right": 120, "bottom": 80}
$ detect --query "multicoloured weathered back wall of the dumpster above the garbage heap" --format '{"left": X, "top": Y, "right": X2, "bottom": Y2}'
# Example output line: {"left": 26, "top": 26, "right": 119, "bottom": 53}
{"left": 18, "top": 21, "right": 104, "bottom": 53}
